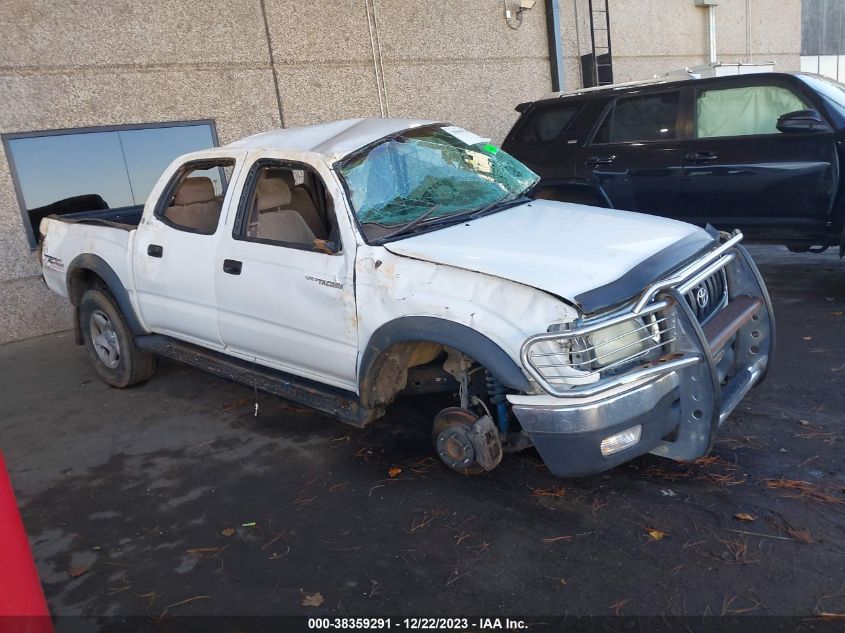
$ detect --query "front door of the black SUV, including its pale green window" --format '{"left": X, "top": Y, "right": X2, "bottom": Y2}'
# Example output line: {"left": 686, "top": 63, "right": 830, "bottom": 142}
{"left": 680, "top": 80, "right": 837, "bottom": 239}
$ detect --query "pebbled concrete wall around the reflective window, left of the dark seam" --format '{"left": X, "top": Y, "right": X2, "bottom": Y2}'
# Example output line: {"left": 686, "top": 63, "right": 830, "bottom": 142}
{"left": 0, "top": 0, "right": 286, "bottom": 342}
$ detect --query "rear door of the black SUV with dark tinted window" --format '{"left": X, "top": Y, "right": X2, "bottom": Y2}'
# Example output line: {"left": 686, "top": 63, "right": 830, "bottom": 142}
{"left": 576, "top": 88, "right": 685, "bottom": 216}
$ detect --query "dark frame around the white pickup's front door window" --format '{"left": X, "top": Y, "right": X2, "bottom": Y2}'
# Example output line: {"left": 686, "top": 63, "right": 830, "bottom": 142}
{"left": 232, "top": 157, "right": 343, "bottom": 256}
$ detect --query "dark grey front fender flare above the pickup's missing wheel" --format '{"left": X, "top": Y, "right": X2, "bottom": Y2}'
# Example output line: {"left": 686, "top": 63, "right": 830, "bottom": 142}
{"left": 358, "top": 316, "right": 530, "bottom": 405}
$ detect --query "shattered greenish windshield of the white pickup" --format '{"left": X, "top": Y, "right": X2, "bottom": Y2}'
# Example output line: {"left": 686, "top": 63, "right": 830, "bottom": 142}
{"left": 338, "top": 126, "right": 539, "bottom": 240}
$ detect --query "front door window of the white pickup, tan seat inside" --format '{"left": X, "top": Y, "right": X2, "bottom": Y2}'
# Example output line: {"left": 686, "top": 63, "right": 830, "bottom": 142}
{"left": 233, "top": 160, "right": 340, "bottom": 254}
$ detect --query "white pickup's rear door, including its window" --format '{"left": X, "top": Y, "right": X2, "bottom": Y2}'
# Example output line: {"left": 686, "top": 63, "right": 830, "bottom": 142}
{"left": 132, "top": 153, "right": 242, "bottom": 348}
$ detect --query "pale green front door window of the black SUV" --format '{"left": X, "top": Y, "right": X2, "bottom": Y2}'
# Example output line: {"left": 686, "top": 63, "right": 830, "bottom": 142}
{"left": 695, "top": 86, "right": 809, "bottom": 138}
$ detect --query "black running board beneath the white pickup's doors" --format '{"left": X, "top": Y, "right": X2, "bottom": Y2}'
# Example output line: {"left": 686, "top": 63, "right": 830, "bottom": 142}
{"left": 135, "top": 334, "right": 382, "bottom": 427}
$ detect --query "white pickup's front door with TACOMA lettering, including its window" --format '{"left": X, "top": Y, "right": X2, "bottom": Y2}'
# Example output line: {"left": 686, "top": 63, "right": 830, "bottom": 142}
{"left": 216, "top": 158, "right": 358, "bottom": 390}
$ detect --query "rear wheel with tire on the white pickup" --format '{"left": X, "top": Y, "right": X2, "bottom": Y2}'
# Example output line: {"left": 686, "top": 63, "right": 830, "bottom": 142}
{"left": 79, "top": 288, "right": 157, "bottom": 388}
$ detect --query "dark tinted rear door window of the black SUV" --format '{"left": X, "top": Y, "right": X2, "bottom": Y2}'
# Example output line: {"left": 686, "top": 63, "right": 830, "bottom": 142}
{"left": 593, "top": 91, "right": 680, "bottom": 143}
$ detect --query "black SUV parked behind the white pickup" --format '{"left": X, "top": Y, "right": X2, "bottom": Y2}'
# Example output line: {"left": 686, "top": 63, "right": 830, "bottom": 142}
{"left": 503, "top": 73, "right": 845, "bottom": 256}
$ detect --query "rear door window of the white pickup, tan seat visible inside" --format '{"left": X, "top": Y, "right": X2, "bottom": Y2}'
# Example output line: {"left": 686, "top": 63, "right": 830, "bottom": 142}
{"left": 155, "top": 158, "right": 235, "bottom": 235}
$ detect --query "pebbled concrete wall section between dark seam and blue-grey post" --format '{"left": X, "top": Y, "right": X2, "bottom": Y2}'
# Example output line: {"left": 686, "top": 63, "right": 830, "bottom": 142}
{"left": 267, "top": 0, "right": 551, "bottom": 140}
